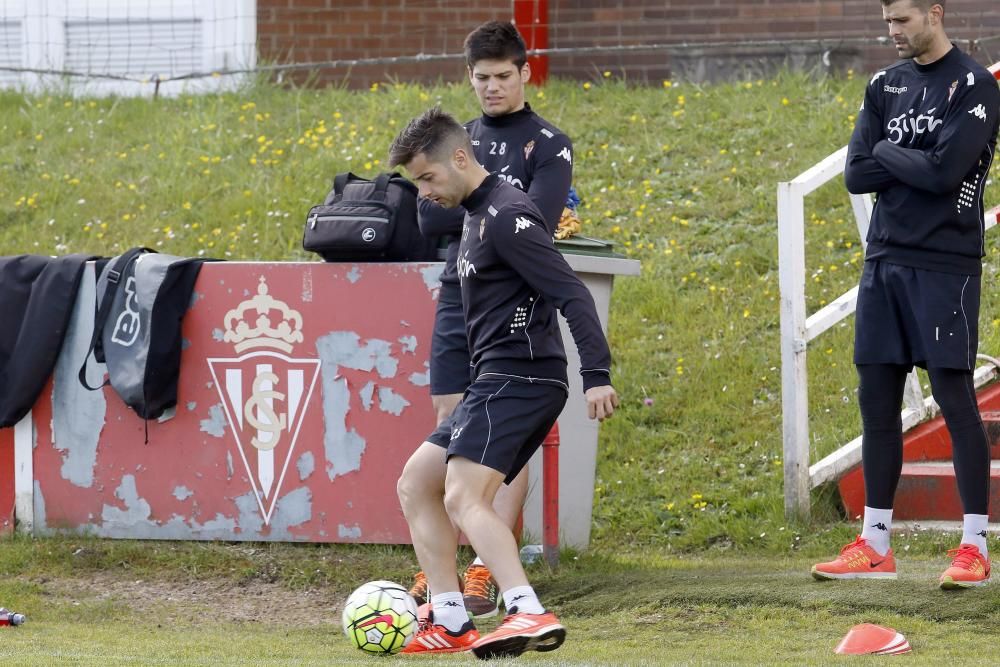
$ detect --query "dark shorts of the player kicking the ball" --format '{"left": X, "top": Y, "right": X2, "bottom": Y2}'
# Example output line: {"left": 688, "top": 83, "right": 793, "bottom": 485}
{"left": 427, "top": 377, "right": 567, "bottom": 484}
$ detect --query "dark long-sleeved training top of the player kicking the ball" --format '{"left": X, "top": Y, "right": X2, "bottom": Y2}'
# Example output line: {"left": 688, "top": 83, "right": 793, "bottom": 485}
{"left": 457, "top": 174, "right": 611, "bottom": 391}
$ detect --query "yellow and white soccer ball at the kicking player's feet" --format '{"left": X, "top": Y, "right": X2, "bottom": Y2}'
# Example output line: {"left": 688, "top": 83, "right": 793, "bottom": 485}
{"left": 343, "top": 581, "right": 417, "bottom": 655}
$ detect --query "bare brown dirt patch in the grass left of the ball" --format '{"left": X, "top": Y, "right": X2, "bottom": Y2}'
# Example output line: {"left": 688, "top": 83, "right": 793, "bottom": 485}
{"left": 34, "top": 573, "right": 343, "bottom": 626}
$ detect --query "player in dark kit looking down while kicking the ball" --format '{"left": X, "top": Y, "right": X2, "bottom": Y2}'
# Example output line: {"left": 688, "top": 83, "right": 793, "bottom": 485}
{"left": 389, "top": 108, "right": 618, "bottom": 659}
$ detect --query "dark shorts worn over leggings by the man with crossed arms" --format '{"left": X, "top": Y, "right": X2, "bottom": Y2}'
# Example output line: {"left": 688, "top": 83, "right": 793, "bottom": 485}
{"left": 854, "top": 261, "right": 981, "bottom": 370}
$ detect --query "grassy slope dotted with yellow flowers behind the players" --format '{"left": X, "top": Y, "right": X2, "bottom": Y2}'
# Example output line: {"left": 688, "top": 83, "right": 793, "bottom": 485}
{"left": 0, "top": 75, "right": 1000, "bottom": 554}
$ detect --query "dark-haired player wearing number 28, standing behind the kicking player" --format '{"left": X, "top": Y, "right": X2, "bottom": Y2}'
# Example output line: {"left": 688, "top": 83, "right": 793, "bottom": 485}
{"left": 403, "top": 21, "right": 573, "bottom": 618}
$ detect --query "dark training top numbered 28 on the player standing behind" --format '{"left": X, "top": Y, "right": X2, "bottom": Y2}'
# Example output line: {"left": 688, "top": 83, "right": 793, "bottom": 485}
{"left": 418, "top": 104, "right": 573, "bottom": 303}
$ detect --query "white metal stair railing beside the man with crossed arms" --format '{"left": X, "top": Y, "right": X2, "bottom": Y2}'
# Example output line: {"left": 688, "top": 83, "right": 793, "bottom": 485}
{"left": 778, "top": 145, "right": 1000, "bottom": 518}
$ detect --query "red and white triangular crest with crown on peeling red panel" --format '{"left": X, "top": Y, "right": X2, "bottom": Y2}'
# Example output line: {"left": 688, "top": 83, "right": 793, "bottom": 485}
{"left": 208, "top": 277, "right": 319, "bottom": 525}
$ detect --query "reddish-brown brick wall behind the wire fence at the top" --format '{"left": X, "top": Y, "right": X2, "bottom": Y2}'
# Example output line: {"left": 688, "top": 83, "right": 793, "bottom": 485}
{"left": 257, "top": 0, "right": 1000, "bottom": 86}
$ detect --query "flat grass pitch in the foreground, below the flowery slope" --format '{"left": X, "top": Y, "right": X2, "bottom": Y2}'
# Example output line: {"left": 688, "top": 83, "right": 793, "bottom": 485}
{"left": 0, "top": 538, "right": 1000, "bottom": 665}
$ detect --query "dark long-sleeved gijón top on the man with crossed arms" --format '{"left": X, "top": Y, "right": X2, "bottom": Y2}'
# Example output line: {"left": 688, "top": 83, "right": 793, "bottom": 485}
{"left": 844, "top": 46, "right": 1000, "bottom": 275}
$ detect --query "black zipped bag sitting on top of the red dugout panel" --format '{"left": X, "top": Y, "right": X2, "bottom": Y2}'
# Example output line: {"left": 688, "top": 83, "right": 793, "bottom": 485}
{"left": 302, "top": 173, "right": 439, "bottom": 262}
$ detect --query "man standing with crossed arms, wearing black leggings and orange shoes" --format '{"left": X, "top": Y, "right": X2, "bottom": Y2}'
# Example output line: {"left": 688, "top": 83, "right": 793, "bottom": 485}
{"left": 812, "top": 0, "right": 1000, "bottom": 589}
